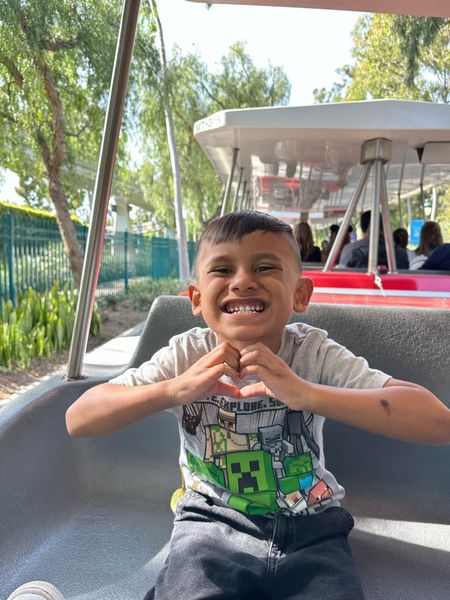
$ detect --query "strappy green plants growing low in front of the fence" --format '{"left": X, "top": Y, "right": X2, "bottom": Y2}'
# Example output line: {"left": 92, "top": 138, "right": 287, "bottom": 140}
{"left": 0, "top": 284, "right": 101, "bottom": 371}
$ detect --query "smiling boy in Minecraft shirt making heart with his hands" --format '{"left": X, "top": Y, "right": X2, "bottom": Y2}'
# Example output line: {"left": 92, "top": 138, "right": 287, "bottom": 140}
{"left": 67, "top": 211, "right": 450, "bottom": 600}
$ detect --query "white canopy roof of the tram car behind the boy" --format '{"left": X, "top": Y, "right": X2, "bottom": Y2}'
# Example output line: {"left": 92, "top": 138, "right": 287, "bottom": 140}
{"left": 194, "top": 100, "right": 450, "bottom": 223}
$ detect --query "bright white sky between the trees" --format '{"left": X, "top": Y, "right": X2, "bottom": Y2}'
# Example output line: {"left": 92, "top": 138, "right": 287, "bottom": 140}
{"left": 0, "top": 0, "right": 362, "bottom": 202}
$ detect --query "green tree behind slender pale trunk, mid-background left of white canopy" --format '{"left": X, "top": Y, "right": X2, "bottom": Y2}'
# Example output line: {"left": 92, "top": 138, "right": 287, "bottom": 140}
{"left": 140, "top": 42, "right": 290, "bottom": 237}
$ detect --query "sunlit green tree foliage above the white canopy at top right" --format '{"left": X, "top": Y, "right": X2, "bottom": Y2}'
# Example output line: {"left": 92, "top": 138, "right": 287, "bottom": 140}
{"left": 314, "top": 14, "right": 450, "bottom": 102}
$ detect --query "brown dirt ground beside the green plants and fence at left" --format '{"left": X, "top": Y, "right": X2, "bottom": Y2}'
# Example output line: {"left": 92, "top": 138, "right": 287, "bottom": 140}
{"left": 0, "top": 300, "right": 148, "bottom": 401}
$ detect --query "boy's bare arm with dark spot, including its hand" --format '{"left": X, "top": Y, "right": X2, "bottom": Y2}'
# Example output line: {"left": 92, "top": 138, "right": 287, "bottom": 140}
{"left": 240, "top": 343, "right": 450, "bottom": 444}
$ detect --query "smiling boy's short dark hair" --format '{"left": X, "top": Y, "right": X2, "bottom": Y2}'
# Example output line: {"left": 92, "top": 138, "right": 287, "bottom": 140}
{"left": 196, "top": 210, "right": 302, "bottom": 269}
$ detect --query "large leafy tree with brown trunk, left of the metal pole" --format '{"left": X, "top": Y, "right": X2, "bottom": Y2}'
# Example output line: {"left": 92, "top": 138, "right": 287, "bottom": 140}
{"left": 0, "top": 0, "right": 146, "bottom": 287}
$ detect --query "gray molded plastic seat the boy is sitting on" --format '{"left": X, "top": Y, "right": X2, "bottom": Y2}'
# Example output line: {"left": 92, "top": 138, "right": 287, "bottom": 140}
{"left": 0, "top": 297, "right": 450, "bottom": 600}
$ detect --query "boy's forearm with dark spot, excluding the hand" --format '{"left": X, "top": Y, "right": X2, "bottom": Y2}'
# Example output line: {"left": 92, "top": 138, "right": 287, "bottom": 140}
{"left": 303, "top": 384, "right": 450, "bottom": 444}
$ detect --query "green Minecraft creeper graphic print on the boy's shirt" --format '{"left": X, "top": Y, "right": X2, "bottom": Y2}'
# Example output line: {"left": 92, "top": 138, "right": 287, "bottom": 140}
{"left": 182, "top": 396, "right": 334, "bottom": 515}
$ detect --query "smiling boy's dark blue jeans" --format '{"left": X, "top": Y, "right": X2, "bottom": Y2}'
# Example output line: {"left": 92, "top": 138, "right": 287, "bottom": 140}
{"left": 145, "top": 492, "right": 364, "bottom": 600}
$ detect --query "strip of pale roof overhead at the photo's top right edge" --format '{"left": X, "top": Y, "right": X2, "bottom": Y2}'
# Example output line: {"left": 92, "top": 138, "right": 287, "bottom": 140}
{"left": 187, "top": 0, "right": 450, "bottom": 17}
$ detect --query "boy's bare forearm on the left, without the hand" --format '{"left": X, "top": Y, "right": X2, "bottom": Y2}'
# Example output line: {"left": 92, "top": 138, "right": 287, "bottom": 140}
{"left": 66, "top": 380, "right": 174, "bottom": 437}
